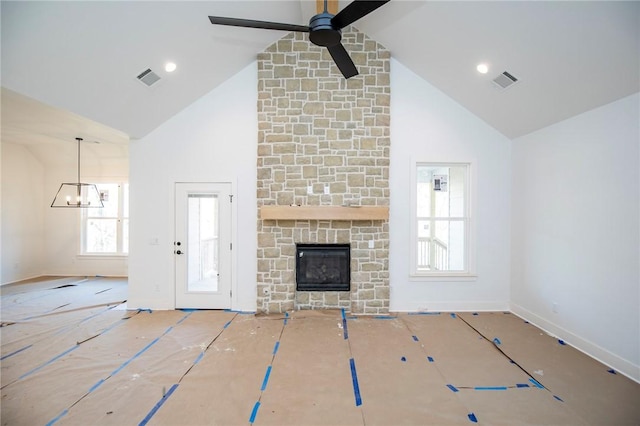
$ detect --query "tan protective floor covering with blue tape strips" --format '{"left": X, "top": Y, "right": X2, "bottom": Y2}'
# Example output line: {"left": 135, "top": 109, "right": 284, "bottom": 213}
{"left": 0, "top": 277, "right": 640, "bottom": 425}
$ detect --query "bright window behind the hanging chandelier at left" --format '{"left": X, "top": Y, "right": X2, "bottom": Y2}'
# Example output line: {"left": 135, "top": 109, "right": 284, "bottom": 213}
{"left": 80, "top": 182, "right": 129, "bottom": 256}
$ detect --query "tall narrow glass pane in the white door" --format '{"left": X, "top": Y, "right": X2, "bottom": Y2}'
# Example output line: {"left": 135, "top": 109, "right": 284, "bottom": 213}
{"left": 186, "top": 194, "right": 218, "bottom": 292}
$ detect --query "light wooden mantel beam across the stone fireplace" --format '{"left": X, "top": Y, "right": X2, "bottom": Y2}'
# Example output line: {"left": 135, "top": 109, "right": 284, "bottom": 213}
{"left": 260, "top": 206, "right": 389, "bottom": 220}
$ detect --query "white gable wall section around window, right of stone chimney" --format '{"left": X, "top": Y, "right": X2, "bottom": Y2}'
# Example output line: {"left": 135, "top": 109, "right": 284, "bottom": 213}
{"left": 389, "top": 60, "right": 511, "bottom": 311}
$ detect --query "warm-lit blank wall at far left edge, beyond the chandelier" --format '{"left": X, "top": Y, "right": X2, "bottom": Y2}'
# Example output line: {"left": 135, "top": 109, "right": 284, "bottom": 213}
{"left": 0, "top": 143, "right": 44, "bottom": 284}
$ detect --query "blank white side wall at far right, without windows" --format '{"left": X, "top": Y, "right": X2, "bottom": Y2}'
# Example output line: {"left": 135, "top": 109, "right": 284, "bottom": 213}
{"left": 512, "top": 94, "right": 640, "bottom": 380}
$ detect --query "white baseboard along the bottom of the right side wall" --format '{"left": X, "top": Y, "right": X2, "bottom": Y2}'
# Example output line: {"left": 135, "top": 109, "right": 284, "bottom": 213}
{"left": 511, "top": 303, "right": 640, "bottom": 383}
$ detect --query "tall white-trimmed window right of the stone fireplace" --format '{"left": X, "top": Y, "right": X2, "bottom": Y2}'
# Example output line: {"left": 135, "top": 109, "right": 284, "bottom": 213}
{"left": 411, "top": 162, "right": 474, "bottom": 277}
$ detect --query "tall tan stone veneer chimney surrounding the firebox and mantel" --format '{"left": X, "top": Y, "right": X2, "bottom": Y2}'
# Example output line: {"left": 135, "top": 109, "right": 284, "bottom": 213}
{"left": 257, "top": 27, "right": 390, "bottom": 314}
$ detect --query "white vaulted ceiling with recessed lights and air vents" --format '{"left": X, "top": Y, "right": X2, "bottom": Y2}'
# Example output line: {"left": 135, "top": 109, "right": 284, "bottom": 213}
{"left": 1, "top": 0, "right": 640, "bottom": 165}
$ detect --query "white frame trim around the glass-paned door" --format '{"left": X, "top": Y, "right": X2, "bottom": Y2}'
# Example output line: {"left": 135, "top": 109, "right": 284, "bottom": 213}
{"left": 171, "top": 179, "right": 238, "bottom": 310}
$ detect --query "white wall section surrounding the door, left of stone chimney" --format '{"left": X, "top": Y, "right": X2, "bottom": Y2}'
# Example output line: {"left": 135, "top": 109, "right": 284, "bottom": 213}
{"left": 128, "top": 62, "right": 258, "bottom": 311}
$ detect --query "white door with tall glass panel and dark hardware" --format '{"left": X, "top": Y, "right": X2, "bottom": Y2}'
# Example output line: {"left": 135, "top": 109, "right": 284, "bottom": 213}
{"left": 174, "top": 183, "right": 231, "bottom": 309}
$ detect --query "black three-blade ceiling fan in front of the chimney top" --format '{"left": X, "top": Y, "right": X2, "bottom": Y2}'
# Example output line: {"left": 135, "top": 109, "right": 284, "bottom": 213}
{"left": 209, "top": 0, "right": 390, "bottom": 78}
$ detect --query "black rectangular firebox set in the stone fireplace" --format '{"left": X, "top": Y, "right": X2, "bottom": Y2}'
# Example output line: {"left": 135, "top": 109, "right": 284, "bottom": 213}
{"left": 296, "top": 244, "right": 351, "bottom": 291}
